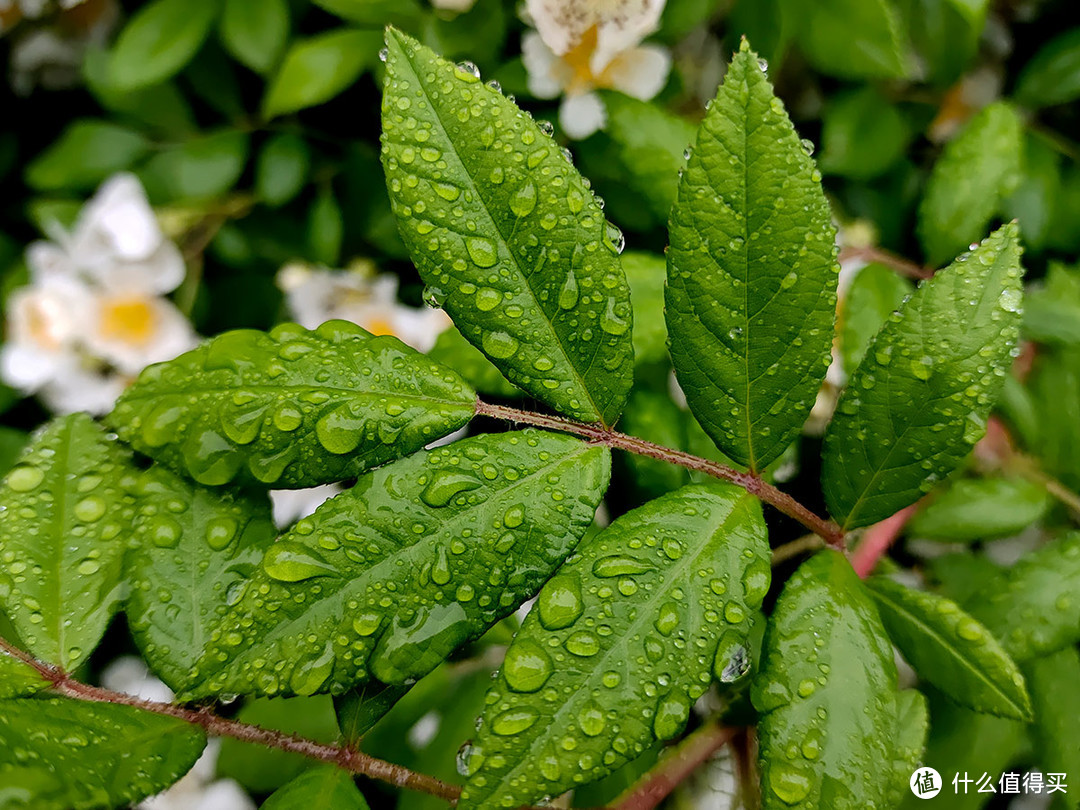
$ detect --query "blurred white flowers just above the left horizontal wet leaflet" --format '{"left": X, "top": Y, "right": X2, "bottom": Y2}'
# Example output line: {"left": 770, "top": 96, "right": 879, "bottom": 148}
{"left": 278, "top": 262, "right": 450, "bottom": 352}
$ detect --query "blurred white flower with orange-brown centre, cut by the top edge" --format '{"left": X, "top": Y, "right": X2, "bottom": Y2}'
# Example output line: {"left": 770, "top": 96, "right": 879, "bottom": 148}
{"left": 522, "top": 0, "right": 672, "bottom": 138}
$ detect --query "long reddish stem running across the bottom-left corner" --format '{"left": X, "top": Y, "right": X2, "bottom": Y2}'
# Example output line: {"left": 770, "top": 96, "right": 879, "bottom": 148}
{"left": 0, "top": 638, "right": 461, "bottom": 802}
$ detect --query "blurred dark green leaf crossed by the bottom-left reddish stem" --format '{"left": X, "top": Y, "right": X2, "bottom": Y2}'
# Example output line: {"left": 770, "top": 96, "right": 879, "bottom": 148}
{"left": 217, "top": 694, "right": 338, "bottom": 794}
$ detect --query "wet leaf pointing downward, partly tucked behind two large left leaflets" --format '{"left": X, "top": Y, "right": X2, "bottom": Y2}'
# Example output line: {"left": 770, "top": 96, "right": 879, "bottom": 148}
{"left": 125, "top": 467, "right": 276, "bottom": 691}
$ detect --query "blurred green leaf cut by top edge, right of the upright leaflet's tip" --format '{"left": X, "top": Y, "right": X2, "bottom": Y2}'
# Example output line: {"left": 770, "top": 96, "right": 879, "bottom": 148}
{"left": 782, "top": 0, "right": 909, "bottom": 79}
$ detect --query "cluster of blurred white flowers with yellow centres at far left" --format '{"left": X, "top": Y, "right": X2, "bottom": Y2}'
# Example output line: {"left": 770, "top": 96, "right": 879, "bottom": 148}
{"left": 0, "top": 174, "right": 195, "bottom": 413}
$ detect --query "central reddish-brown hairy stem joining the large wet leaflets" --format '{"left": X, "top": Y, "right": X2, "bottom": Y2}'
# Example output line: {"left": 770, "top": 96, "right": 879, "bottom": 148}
{"left": 476, "top": 400, "right": 843, "bottom": 551}
